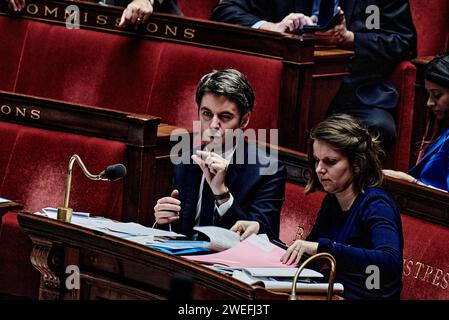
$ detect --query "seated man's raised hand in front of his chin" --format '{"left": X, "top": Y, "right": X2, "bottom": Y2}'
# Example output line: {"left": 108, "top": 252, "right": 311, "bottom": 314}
{"left": 192, "top": 151, "right": 229, "bottom": 195}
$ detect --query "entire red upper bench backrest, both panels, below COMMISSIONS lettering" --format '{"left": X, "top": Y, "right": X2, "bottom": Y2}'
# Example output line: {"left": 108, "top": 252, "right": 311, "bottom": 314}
{"left": 0, "top": 17, "right": 283, "bottom": 132}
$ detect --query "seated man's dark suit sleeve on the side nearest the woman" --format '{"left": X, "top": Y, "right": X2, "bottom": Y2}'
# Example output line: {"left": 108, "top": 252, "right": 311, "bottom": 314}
{"left": 215, "top": 166, "right": 287, "bottom": 239}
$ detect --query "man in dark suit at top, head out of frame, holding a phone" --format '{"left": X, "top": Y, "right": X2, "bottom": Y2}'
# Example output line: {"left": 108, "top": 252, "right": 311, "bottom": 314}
{"left": 211, "top": 0, "right": 416, "bottom": 147}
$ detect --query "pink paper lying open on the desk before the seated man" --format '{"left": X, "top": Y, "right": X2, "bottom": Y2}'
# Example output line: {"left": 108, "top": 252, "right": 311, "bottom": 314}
{"left": 183, "top": 235, "right": 291, "bottom": 268}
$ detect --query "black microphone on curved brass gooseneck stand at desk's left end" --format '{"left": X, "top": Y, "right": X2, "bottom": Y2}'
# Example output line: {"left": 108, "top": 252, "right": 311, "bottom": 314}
{"left": 57, "top": 154, "right": 126, "bottom": 222}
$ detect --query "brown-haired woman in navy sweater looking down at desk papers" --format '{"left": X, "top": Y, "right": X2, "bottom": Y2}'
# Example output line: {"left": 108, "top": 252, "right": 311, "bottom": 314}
{"left": 281, "top": 115, "right": 403, "bottom": 299}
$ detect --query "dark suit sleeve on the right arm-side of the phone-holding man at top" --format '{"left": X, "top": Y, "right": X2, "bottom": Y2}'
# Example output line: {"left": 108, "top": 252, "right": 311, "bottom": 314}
{"left": 349, "top": 0, "right": 416, "bottom": 66}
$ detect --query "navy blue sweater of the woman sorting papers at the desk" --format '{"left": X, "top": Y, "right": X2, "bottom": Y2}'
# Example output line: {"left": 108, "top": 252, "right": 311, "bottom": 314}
{"left": 308, "top": 192, "right": 403, "bottom": 298}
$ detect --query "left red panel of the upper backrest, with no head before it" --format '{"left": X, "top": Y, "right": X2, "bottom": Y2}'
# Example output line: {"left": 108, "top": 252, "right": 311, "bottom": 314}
{"left": 15, "top": 22, "right": 163, "bottom": 113}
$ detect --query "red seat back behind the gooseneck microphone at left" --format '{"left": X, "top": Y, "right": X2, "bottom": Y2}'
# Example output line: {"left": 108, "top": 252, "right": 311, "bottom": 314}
{"left": 0, "top": 122, "right": 126, "bottom": 220}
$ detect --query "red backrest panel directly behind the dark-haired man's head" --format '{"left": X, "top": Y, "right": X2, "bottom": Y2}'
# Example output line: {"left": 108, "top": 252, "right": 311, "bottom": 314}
{"left": 147, "top": 43, "right": 282, "bottom": 129}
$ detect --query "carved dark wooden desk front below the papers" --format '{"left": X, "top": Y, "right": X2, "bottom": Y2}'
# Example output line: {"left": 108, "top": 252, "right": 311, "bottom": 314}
{"left": 18, "top": 212, "right": 338, "bottom": 300}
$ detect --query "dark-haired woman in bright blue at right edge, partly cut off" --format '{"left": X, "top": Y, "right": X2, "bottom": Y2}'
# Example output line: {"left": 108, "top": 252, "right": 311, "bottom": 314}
{"left": 384, "top": 53, "right": 449, "bottom": 191}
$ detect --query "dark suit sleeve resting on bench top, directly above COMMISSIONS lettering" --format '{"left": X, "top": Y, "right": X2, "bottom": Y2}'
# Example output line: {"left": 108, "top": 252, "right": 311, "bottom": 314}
{"left": 209, "top": 0, "right": 270, "bottom": 27}
